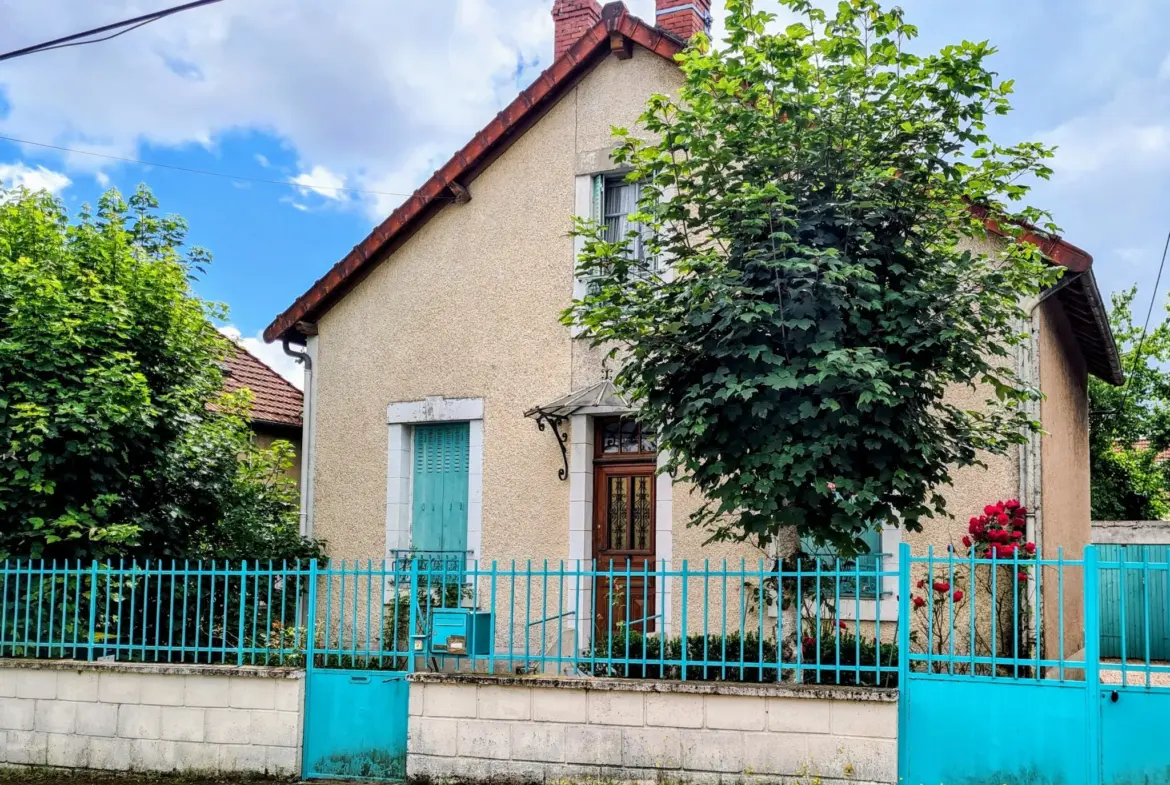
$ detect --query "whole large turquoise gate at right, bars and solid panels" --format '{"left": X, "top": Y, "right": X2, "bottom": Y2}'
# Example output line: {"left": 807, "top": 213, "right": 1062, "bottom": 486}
{"left": 899, "top": 545, "right": 1170, "bottom": 785}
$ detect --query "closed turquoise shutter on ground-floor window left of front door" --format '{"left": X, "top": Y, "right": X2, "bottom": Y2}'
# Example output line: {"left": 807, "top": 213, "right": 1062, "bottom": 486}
{"left": 411, "top": 422, "right": 470, "bottom": 552}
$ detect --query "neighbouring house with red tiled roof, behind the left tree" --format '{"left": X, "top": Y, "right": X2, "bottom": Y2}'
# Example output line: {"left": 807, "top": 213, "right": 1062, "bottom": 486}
{"left": 222, "top": 342, "right": 304, "bottom": 484}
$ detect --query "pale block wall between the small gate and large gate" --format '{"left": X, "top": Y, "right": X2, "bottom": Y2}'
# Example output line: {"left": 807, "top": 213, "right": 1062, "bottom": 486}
{"left": 407, "top": 674, "right": 897, "bottom": 785}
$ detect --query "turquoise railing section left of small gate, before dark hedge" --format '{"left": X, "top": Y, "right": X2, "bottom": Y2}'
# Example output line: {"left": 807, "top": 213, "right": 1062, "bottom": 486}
{"left": 0, "top": 559, "right": 314, "bottom": 666}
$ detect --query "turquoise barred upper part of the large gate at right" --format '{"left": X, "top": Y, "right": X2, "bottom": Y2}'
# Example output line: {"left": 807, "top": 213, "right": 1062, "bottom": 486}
{"left": 900, "top": 545, "right": 1170, "bottom": 687}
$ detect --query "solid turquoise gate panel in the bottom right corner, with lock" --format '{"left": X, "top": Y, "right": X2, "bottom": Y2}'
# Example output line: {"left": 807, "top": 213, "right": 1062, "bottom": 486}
{"left": 1101, "top": 687, "right": 1170, "bottom": 785}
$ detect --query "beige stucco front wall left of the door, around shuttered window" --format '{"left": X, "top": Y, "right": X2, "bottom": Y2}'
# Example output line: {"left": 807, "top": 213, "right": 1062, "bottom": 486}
{"left": 314, "top": 49, "right": 681, "bottom": 570}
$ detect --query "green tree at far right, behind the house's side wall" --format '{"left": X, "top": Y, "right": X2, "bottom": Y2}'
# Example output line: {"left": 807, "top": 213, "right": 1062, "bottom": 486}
{"left": 1089, "top": 287, "right": 1170, "bottom": 521}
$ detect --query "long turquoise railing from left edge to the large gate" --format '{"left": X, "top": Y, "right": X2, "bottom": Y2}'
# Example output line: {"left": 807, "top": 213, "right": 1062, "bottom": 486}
{"left": 0, "top": 553, "right": 897, "bottom": 686}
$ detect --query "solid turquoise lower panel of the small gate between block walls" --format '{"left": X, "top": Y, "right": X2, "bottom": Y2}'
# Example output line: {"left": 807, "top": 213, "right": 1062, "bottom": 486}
{"left": 303, "top": 669, "right": 410, "bottom": 780}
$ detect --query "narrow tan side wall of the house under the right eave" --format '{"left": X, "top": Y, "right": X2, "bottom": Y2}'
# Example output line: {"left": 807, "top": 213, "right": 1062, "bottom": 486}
{"left": 1040, "top": 297, "right": 1092, "bottom": 652}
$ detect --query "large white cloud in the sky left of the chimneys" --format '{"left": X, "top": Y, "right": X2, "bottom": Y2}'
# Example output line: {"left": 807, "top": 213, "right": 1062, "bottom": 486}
{"left": 0, "top": 0, "right": 559, "bottom": 220}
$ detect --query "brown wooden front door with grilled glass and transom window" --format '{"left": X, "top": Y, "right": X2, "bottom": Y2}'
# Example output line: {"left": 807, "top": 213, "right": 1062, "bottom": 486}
{"left": 593, "top": 419, "right": 658, "bottom": 635}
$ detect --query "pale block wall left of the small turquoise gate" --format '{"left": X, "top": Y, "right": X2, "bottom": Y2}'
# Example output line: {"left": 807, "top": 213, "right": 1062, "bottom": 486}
{"left": 0, "top": 660, "right": 304, "bottom": 776}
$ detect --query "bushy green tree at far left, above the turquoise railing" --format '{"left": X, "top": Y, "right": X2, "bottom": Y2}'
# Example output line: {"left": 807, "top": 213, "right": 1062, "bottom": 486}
{"left": 0, "top": 186, "right": 317, "bottom": 559}
